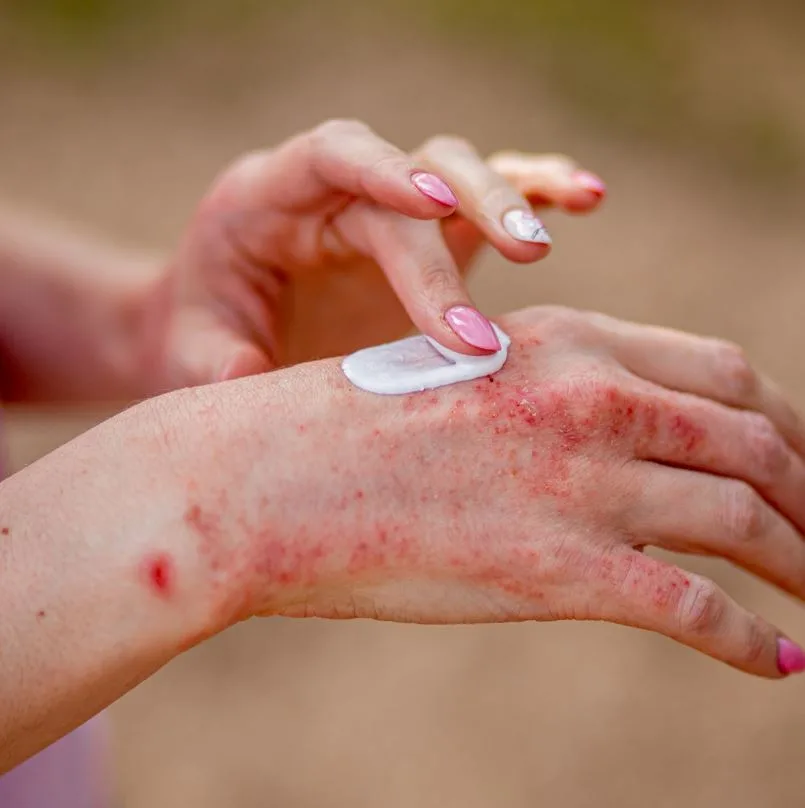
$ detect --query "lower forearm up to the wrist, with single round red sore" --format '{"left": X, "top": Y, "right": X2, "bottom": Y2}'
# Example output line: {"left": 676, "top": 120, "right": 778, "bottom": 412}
{"left": 0, "top": 394, "right": 225, "bottom": 773}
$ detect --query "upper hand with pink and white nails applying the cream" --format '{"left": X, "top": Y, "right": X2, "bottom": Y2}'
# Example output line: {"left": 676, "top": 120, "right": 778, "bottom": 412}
{"left": 147, "top": 121, "right": 604, "bottom": 388}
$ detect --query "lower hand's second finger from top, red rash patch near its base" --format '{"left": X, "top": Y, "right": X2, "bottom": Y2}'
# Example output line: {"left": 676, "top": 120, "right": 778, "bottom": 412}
{"left": 634, "top": 390, "right": 805, "bottom": 531}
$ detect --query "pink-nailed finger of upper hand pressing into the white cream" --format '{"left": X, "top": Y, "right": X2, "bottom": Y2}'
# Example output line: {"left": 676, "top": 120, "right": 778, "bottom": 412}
{"left": 334, "top": 204, "right": 500, "bottom": 355}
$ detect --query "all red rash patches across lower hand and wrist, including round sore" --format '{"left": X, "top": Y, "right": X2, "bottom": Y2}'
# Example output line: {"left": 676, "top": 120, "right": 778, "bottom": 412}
{"left": 170, "top": 360, "right": 707, "bottom": 611}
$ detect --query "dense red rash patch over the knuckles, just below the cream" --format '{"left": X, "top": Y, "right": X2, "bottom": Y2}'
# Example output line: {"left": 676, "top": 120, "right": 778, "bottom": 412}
{"left": 398, "top": 368, "right": 707, "bottom": 507}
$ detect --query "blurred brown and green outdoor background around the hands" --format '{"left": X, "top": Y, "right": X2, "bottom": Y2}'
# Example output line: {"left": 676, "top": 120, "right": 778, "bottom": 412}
{"left": 0, "top": 0, "right": 805, "bottom": 808}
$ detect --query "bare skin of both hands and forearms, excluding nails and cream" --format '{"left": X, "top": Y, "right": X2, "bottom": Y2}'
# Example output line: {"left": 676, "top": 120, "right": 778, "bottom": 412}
{"left": 0, "top": 122, "right": 805, "bottom": 771}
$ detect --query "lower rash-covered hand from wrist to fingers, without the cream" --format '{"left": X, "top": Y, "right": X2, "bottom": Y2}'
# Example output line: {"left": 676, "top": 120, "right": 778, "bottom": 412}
{"left": 200, "top": 308, "right": 805, "bottom": 677}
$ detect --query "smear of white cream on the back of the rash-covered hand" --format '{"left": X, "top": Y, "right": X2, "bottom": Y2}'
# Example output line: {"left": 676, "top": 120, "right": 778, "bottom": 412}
{"left": 341, "top": 324, "right": 511, "bottom": 395}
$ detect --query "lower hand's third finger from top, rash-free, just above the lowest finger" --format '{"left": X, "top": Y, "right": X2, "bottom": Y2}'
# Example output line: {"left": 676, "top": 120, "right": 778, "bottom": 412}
{"left": 628, "top": 463, "right": 805, "bottom": 599}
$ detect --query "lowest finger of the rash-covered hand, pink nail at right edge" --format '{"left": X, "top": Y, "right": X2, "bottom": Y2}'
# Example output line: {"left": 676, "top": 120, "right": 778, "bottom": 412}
{"left": 594, "top": 550, "right": 805, "bottom": 679}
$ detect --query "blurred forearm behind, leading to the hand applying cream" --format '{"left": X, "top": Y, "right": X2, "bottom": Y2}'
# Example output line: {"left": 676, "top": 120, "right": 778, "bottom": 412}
{"left": 0, "top": 208, "right": 163, "bottom": 402}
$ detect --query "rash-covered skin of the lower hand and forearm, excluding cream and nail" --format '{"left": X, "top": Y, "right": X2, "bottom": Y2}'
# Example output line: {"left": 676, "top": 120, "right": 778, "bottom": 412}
{"left": 0, "top": 309, "right": 805, "bottom": 769}
